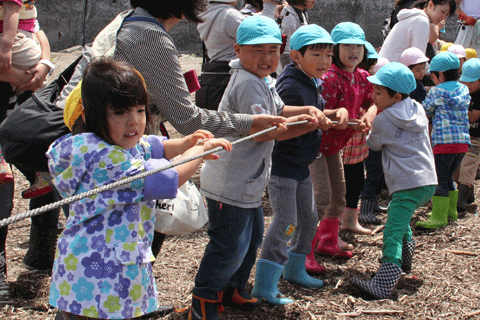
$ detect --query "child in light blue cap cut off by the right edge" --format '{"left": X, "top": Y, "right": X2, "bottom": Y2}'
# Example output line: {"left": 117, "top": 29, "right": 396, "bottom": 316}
{"left": 457, "top": 58, "right": 480, "bottom": 212}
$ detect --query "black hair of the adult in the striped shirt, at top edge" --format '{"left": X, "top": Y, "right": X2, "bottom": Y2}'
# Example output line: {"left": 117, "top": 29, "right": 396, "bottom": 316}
{"left": 130, "top": 0, "right": 208, "bottom": 23}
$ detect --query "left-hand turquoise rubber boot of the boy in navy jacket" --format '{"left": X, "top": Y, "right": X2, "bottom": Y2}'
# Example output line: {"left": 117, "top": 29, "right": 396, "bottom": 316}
{"left": 252, "top": 259, "right": 292, "bottom": 305}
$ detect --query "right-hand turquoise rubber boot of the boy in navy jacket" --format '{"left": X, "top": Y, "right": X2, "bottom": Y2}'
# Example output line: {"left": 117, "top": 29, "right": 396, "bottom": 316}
{"left": 283, "top": 251, "right": 323, "bottom": 289}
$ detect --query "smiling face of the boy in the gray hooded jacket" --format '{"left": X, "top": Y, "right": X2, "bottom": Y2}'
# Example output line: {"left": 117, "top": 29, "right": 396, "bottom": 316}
{"left": 234, "top": 43, "right": 280, "bottom": 78}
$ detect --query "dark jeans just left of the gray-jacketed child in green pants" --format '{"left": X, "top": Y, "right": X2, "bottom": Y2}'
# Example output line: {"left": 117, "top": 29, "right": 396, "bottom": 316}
{"left": 361, "top": 149, "right": 385, "bottom": 200}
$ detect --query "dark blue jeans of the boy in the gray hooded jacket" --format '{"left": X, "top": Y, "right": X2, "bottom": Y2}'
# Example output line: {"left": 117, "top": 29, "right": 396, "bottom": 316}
{"left": 194, "top": 198, "right": 264, "bottom": 300}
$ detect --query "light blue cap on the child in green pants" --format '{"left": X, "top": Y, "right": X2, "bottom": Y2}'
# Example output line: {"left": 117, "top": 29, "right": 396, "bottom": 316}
{"left": 367, "top": 62, "right": 417, "bottom": 94}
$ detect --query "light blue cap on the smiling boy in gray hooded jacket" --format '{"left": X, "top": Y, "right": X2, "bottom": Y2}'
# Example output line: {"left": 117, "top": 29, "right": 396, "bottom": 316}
{"left": 237, "top": 15, "right": 282, "bottom": 45}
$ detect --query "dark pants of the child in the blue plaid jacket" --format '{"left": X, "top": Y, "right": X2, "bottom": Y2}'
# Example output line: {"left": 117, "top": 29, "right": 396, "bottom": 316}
{"left": 434, "top": 153, "right": 465, "bottom": 197}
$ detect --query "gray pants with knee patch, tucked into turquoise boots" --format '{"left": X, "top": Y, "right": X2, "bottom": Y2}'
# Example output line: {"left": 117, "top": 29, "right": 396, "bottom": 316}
{"left": 260, "top": 175, "right": 318, "bottom": 265}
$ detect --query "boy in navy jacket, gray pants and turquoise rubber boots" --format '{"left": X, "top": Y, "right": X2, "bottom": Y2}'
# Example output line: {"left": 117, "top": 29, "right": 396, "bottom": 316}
{"left": 252, "top": 24, "right": 342, "bottom": 304}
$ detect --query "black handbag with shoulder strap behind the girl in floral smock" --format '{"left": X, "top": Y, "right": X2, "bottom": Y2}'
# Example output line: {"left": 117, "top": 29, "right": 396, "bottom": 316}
{"left": 0, "top": 56, "right": 82, "bottom": 172}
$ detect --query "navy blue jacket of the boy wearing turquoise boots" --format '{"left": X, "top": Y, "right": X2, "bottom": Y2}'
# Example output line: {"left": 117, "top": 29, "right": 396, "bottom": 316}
{"left": 272, "top": 64, "right": 325, "bottom": 181}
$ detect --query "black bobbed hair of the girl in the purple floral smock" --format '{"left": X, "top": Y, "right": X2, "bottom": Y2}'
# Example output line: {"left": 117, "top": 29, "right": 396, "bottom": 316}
{"left": 80, "top": 57, "right": 150, "bottom": 142}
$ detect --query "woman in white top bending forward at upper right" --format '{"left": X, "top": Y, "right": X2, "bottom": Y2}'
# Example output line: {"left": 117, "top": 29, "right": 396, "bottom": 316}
{"left": 379, "top": 0, "right": 457, "bottom": 62}
